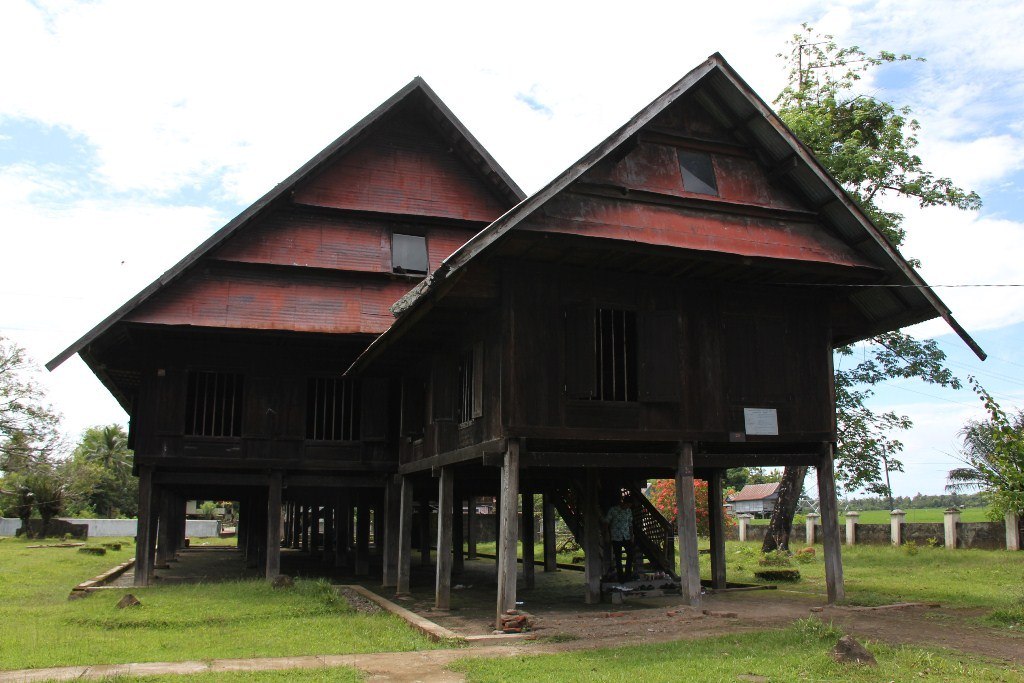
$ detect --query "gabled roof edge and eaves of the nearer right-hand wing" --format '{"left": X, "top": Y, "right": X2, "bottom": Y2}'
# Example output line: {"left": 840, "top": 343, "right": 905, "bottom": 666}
{"left": 350, "top": 52, "right": 985, "bottom": 371}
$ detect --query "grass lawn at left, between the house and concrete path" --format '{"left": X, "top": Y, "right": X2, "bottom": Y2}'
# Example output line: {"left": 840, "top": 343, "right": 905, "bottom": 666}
{"left": 0, "top": 538, "right": 433, "bottom": 669}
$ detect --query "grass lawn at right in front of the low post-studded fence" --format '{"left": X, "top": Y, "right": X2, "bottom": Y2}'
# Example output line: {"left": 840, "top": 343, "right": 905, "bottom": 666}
{"left": 700, "top": 541, "right": 1024, "bottom": 624}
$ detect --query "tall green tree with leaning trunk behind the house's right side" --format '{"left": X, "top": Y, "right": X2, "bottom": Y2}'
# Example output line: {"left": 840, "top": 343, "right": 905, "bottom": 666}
{"left": 763, "top": 24, "right": 981, "bottom": 552}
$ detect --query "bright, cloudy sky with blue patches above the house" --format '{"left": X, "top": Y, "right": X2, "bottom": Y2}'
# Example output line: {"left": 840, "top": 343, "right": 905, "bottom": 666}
{"left": 0, "top": 0, "right": 1024, "bottom": 495}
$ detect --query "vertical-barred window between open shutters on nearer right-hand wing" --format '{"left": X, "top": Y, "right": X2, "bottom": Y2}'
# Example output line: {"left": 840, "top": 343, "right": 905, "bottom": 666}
{"left": 594, "top": 308, "right": 637, "bottom": 400}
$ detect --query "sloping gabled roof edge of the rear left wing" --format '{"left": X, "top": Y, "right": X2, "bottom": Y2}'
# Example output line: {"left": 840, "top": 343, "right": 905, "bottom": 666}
{"left": 46, "top": 76, "right": 525, "bottom": 371}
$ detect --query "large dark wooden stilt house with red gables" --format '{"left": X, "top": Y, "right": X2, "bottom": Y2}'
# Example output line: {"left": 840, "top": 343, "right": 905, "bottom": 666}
{"left": 50, "top": 54, "right": 981, "bottom": 626}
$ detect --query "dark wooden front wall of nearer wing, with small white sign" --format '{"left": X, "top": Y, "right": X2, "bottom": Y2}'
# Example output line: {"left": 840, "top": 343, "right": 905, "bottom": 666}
{"left": 503, "top": 265, "right": 833, "bottom": 441}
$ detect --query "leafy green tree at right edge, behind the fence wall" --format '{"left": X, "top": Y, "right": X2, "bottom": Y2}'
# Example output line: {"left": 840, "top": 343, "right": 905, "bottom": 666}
{"left": 946, "top": 377, "right": 1024, "bottom": 518}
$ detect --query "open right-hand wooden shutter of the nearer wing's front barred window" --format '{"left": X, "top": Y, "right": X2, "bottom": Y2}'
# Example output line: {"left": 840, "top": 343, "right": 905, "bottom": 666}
{"left": 637, "top": 310, "right": 683, "bottom": 402}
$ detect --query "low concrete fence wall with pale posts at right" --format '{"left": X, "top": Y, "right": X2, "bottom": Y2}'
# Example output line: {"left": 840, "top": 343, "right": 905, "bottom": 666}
{"left": 726, "top": 511, "right": 1024, "bottom": 550}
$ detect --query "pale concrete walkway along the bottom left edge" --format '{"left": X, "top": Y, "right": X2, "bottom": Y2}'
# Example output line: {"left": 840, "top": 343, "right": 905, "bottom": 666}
{"left": 0, "top": 645, "right": 544, "bottom": 683}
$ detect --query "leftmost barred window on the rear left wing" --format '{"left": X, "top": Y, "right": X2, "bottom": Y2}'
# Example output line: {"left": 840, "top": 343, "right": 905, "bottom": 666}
{"left": 185, "top": 371, "right": 242, "bottom": 436}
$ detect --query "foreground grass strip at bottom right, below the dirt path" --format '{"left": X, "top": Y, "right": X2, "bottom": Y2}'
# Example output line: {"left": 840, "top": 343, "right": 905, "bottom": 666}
{"left": 452, "top": 618, "right": 1024, "bottom": 683}
